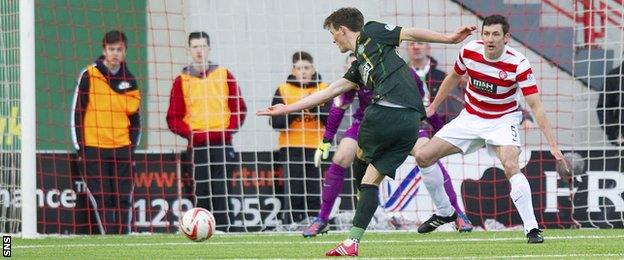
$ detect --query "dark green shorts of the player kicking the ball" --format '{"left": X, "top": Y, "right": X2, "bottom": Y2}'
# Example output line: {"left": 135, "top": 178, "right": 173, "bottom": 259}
{"left": 358, "top": 104, "right": 421, "bottom": 178}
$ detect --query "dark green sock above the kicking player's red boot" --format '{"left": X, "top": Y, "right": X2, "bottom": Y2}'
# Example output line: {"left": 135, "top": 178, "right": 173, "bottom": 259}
{"left": 349, "top": 184, "right": 379, "bottom": 241}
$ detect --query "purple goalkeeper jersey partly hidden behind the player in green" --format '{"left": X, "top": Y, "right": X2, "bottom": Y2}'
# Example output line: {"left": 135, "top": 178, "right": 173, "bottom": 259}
{"left": 323, "top": 69, "right": 444, "bottom": 141}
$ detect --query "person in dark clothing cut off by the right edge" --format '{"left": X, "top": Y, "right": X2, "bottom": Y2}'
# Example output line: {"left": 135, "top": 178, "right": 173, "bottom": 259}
{"left": 597, "top": 62, "right": 624, "bottom": 146}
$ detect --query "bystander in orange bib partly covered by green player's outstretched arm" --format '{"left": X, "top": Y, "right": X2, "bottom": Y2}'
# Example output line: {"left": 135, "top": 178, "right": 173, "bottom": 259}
{"left": 270, "top": 51, "right": 331, "bottom": 225}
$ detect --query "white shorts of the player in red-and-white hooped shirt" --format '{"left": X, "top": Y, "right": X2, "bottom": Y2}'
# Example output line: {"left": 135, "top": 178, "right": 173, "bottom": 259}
{"left": 435, "top": 109, "right": 522, "bottom": 156}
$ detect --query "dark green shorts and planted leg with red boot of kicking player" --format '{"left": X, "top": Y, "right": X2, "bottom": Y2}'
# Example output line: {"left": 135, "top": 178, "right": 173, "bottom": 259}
{"left": 325, "top": 104, "right": 420, "bottom": 256}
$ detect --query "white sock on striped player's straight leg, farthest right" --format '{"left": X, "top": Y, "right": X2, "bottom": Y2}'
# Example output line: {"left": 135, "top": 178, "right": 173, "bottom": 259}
{"left": 509, "top": 173, "right": 538, "bottom": 234}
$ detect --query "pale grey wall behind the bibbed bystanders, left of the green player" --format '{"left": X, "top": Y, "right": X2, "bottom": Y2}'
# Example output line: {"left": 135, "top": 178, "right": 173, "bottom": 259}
{"left": 147, "top": 0, "right": 381, "bottom": 151}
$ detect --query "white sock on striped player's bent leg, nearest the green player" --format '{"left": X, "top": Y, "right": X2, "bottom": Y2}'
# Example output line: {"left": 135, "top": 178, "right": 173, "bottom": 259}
{"left": 420, "top": 163, "right": 453, "bottom": 217}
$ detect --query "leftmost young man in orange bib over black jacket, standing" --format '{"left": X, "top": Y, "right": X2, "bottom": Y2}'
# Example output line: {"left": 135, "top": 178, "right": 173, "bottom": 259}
{"left": 71, "top": 31, "right": 141, "bottom": 234}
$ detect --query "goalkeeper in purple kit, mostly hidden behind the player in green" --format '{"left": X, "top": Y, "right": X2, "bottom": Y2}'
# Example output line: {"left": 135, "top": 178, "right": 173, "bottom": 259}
{"left": 303, "top": 54, "right": 473, "bottom": 237}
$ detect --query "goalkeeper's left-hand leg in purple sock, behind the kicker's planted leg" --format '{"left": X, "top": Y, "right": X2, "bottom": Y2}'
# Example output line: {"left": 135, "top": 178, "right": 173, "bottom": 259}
{"left": 303, "top": 136, "right": 357, "bottom": 237}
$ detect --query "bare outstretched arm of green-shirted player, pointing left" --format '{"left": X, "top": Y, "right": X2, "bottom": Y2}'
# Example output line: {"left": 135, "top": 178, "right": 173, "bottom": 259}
{"left": 256, "top": 78, "right": 357, "bottom": 116}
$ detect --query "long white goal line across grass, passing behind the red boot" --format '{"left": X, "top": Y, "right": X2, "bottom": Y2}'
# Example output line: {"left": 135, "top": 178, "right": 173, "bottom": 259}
{"left": 13, "top": 235, "right": 624, "bottom": 249}
